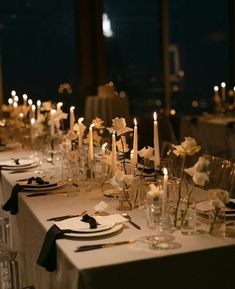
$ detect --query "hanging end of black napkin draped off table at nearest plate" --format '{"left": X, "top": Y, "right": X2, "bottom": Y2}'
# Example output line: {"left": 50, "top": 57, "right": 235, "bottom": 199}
{"left": 37, "top": 225, "right": 64, "bottom": 272}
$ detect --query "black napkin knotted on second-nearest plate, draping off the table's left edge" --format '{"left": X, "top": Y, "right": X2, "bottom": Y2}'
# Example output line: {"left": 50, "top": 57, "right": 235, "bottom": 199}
{"left": 2, "top": 177, "right": 49, "bottom": 215}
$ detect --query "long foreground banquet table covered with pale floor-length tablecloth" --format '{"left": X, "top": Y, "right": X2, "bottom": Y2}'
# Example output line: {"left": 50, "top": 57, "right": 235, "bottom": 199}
{"left": 0, "top": 148, "right": 235, "bottom": 289}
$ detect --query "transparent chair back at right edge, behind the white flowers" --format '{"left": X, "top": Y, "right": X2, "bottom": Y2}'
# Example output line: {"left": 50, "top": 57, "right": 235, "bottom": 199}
{"left": 204, "top": 155, "right": 235, "bottom": 197}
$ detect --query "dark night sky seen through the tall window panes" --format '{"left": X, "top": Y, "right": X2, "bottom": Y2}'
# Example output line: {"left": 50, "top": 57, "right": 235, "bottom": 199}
{"left": 0, "top": 0, "right": 229, "bottom": 115}
